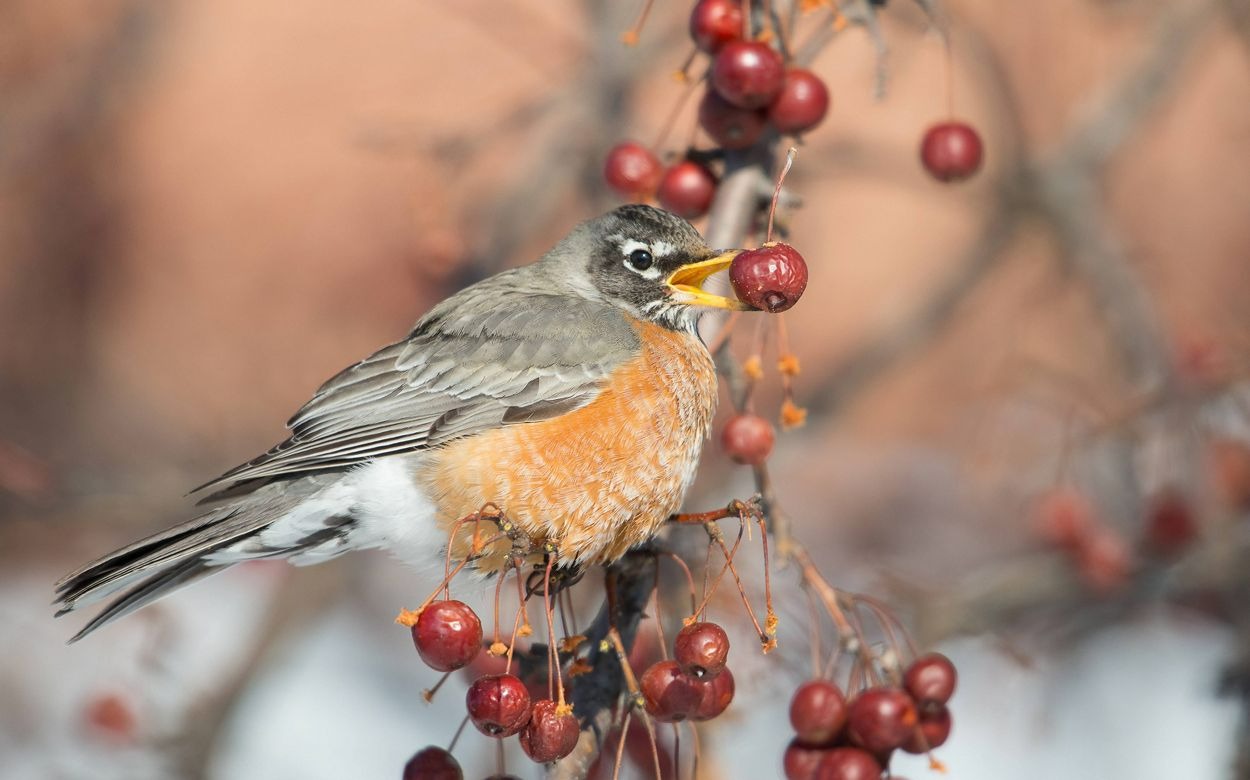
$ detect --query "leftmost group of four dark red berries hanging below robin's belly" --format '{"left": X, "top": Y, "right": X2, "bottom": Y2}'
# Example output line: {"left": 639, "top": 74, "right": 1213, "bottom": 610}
{"left": 404, "top": 599, "right": 580, "bottom": 780}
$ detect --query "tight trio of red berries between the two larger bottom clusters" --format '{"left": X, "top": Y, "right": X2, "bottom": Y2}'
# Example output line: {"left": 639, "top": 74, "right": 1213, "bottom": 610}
{"left": 639, "top": 623, "right": 734, "bottom": 723}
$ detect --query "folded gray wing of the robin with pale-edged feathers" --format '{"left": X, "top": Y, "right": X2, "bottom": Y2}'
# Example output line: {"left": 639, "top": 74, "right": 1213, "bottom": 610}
{"left": 196, "top": 280, "right": 639, "bottom": 500}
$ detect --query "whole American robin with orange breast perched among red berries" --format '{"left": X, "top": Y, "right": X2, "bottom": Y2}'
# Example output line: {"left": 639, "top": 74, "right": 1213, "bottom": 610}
{"left": 56, "top": 205, "right": 746, "bottom": 641}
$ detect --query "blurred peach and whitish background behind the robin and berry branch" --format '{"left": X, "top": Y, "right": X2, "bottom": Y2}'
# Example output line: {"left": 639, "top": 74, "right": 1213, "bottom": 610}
{"left": 0, "top": 0, "right": 1250, "bottom": 780}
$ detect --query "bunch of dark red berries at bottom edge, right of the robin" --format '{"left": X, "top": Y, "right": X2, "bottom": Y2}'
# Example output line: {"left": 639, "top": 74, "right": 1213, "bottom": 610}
{"left": 783, "top": 653, "right": 956, "bottom": 780}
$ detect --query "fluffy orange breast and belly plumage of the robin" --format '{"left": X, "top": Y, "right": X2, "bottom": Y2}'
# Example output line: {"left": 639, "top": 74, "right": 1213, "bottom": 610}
{"left": 416, "top": 324, "right": 716, "bottom": 563}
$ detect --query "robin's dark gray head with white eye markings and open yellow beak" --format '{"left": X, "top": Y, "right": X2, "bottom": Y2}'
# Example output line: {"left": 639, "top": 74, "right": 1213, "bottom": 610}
{"left": 546, "top": 205, "right": 749, "bottom": 330}
